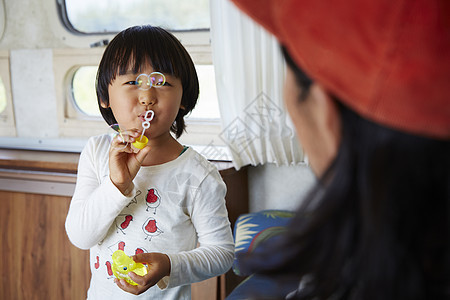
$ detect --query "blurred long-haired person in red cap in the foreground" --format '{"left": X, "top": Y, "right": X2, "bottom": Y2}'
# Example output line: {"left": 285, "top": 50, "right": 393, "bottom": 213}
{"left": 233, "top": 0, "right": 450, "bottom": 300}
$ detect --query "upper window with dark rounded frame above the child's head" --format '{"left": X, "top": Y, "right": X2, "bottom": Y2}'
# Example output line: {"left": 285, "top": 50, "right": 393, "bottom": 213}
{"left": 48, "top": 0, "right": 211, "bottom": 47}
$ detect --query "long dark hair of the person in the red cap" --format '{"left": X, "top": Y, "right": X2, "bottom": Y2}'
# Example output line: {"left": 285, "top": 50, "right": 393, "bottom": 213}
{"left": 240, "top": 48, "right": 450, "bottom": 300}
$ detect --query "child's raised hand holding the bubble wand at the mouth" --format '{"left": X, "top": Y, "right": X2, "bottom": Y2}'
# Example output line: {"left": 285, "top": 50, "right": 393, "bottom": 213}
{"left": 109, "top": 131, "right": 150, "bottom": 195}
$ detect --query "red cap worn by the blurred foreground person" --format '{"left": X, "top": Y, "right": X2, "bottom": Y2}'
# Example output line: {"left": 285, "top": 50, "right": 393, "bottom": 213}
{"left": 233, "top": 0, "right": 450, "bottom": 139}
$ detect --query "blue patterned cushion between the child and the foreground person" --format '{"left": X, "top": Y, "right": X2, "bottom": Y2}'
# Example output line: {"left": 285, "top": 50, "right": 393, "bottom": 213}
{"left": 233, "top": 210, "right": 294, "bottom": 276}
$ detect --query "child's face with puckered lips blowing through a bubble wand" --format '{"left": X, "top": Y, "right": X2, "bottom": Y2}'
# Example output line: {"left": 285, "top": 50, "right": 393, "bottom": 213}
{"left": 108, "top": 66, "right": 183, "bottom": 140}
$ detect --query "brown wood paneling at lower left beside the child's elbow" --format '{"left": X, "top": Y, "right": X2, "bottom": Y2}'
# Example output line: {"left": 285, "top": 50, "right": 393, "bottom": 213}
{"left": 0, "top": 191, "right": 90, "bottom": 300}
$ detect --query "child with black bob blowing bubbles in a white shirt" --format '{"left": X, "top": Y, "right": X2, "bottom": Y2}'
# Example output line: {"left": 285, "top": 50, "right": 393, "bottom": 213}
{"left": 66, "top": 26, "right": 234, "bottom": 299}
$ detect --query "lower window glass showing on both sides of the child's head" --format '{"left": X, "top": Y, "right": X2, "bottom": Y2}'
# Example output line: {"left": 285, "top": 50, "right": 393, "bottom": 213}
{"left": 70, "top": 65, "right": 220, "bottom": 120}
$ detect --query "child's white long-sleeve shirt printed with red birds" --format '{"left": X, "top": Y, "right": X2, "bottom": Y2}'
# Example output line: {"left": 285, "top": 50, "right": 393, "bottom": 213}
{"left": 66, "top": 135, "right": 234, "bottom": 300}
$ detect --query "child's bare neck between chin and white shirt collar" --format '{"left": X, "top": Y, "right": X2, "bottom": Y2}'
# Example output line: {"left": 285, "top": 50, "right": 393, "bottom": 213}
{"left": 142, "top": 133, "right": 183, "bottom": 167}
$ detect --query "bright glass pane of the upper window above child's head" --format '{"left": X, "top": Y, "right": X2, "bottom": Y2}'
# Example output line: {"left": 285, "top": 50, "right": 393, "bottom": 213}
{"left": 63, "top": 0, "right": 210, "bottom": 33}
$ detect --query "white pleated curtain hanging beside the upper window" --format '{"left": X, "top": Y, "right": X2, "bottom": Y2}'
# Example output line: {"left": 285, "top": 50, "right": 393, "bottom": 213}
{"left": 210, "top": 0, "right": 303, "bottom": 169}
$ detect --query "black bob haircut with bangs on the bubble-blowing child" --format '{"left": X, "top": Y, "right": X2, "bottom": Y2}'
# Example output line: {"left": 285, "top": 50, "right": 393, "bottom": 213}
{"left": 96, "top": 25, "right": 199, "bottom": 138}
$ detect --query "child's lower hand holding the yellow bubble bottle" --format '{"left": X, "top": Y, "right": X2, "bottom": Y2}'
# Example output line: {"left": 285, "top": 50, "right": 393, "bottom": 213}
{"left": 114, "top": 252, "right": 170, "bottom": 295}
